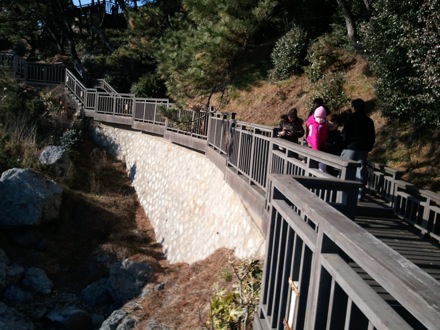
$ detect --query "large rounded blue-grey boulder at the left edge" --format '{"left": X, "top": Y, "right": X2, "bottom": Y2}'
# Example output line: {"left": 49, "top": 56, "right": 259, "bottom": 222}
{"left": 0, "top": 168, "right": 63, "bottom": 226}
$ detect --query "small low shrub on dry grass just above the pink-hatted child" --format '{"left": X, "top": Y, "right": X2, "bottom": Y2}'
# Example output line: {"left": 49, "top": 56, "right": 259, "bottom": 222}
{"left": 312, "top": 72, "right": 349, "bottom": 113}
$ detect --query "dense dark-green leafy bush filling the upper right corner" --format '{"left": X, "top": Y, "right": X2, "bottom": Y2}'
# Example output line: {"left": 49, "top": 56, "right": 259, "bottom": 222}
{"left": 362, "top": 0, "right": 440, "bottom": 127}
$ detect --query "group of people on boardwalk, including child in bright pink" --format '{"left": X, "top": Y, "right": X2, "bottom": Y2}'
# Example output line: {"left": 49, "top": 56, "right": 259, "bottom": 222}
{"left": 278, "top": 98, "right": 376, "bottom": 200}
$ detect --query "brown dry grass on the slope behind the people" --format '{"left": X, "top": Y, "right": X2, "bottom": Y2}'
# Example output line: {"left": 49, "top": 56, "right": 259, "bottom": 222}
{"left": 214, "top": 56, "right": 440, "bottom": 192}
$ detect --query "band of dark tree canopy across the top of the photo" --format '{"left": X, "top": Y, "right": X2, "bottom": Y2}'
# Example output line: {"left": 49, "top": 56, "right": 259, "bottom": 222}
{"left": 0, "top": 0, "right": 440, "bottom": 126}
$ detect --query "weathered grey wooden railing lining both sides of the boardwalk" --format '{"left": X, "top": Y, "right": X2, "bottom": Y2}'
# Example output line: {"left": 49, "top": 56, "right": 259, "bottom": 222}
{"left": 4, "top": 51, "right": 440, "bottom": 329}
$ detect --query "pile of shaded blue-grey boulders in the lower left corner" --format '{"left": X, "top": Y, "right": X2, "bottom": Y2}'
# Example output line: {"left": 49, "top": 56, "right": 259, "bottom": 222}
{"left": 0, "top": 168, "right": 154, "bottom": 330}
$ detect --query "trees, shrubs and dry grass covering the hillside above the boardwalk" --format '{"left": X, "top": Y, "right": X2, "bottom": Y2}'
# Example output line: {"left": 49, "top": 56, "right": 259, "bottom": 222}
{"left": 0, "top": 0, "right": 440, "bottom": 191}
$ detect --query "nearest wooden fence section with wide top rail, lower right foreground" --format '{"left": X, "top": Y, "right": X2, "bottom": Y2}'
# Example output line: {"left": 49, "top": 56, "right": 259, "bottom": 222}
{"left": 254, "top": 174, "right": 440, "bottom": 329}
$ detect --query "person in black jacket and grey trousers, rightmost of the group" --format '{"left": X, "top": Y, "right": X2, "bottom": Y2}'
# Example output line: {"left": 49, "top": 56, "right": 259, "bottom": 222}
{"left": 341, "top": 99, "right": 376, "bottom": 200}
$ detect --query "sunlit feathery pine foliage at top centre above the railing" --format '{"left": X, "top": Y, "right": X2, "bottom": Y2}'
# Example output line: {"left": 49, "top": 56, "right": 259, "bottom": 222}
{"left": 155, "top": 0, "right": 275, "bottom": 104}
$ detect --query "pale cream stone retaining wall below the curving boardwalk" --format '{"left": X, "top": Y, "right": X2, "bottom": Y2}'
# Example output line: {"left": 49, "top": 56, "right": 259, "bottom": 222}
{"left": 92, "top": 123, "right": 265, "bottom": 263}
